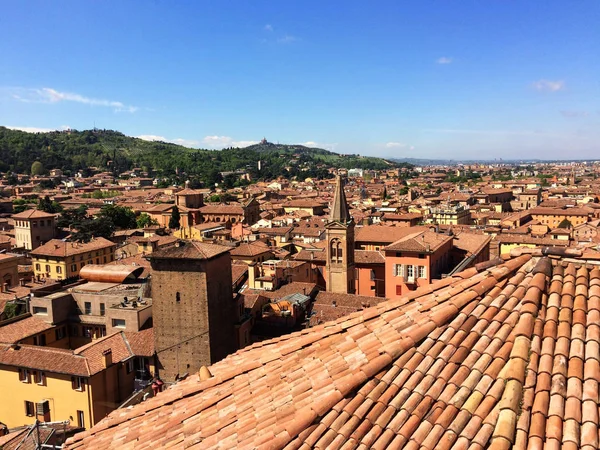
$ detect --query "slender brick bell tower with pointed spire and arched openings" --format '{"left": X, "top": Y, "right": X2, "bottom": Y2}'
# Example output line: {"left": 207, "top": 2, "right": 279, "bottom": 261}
{"left": 325, "top": 175, "right": 355, "bottom": 294}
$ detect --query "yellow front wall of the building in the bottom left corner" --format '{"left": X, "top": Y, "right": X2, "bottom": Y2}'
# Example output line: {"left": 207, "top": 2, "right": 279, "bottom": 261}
{"left": 0, "top": 365, "right": 91, "bottom": 428}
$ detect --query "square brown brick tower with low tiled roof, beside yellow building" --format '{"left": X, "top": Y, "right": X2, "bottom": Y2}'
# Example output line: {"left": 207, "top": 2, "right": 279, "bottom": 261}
{"left": 149, "top": 241, "right": 237, "bottom": 381}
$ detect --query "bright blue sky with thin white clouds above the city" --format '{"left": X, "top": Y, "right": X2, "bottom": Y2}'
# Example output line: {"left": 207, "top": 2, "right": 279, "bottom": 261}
{"left": 0, "top": 0, "right": 600, "bottom": 159}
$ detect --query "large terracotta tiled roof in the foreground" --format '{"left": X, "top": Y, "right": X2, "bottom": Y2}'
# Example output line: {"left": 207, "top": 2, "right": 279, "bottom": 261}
{"left": 67, "top": 255, "right": 600, "bottom": 450}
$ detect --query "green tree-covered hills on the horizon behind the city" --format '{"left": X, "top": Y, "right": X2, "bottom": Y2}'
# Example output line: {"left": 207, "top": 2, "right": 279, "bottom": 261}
{"left": 0, "top": 127, "right": 405, "bottom": 186}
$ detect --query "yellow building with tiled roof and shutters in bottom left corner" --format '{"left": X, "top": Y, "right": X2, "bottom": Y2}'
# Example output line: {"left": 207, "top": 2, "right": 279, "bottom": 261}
{"left": 0, "top": 332, "right": 155, "bottom": 428}
